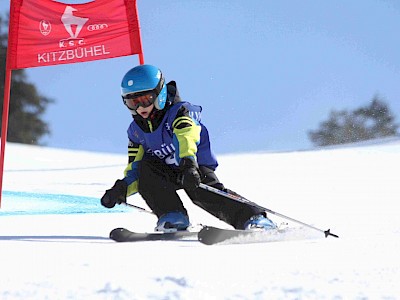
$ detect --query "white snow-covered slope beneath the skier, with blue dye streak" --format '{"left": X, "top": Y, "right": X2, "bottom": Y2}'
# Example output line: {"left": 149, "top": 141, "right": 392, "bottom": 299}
{"left": 0, "top": 139, "right": 400, "bottom": 299}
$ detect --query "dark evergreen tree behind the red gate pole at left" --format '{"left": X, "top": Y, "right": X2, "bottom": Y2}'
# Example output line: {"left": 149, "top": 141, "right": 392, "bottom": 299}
{"left": 0, "top": 16, "right": 53, "bottom": 145}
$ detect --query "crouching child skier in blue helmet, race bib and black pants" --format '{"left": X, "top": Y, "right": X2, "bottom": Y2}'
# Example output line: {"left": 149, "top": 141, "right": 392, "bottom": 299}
{"left": 101, "top": 65, "right": 276, "bottom": 231}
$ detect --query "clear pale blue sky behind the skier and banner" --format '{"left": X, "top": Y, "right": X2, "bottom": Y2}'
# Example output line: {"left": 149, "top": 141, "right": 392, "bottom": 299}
{"left": 0, "top": 0, "right": 400, "bottom": 154}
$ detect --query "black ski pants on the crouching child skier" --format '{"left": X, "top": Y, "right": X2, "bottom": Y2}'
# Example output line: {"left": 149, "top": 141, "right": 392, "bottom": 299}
{"left": 139, "top": 159, "right": 264, "bottom": 229}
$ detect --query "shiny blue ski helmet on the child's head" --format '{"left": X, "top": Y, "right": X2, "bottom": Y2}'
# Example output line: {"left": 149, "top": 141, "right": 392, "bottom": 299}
{"left": 121, "top": 65, "right": 167, "bottom": 115}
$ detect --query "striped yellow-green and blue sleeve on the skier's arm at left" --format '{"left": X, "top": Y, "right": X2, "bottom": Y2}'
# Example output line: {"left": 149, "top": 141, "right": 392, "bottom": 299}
{"left": 124, "top": 141, "right": 144, "bottom": 196}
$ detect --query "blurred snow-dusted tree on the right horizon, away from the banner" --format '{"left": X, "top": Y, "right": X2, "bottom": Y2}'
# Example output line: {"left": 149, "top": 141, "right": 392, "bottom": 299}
{"left": 308, "top": 96, "right": 399, "bottom": 146}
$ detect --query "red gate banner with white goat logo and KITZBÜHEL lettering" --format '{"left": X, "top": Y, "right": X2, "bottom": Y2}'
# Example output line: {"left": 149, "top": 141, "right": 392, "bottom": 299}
{"left": 8, "top": 0, "right": 142, "bottom": 69}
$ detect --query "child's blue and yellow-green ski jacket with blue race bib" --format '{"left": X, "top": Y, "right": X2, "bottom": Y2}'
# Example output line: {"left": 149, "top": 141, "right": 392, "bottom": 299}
{"left": 124, "top": 81, "right": 218, "bottom": 196}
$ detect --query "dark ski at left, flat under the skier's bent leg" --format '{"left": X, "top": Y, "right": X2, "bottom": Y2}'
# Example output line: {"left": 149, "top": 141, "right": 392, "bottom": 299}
{"left": 110, "top": 228, "right": 198, "bottom": 242}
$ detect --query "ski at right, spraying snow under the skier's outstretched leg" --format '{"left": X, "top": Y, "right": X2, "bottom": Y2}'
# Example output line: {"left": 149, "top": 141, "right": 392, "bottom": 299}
{"left": 198, "top": 226, "right": 280, "bottom": 245}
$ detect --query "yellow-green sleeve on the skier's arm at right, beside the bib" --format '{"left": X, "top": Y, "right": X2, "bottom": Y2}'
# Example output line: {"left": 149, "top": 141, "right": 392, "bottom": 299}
{"left": 172, "top": 106, "right": 201, "bottom": 165}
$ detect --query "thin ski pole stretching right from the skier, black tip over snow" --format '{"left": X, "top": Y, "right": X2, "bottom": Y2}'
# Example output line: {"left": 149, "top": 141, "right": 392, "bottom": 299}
{"left": 199, "top": 183, "right": 339, "bottom": 238}
